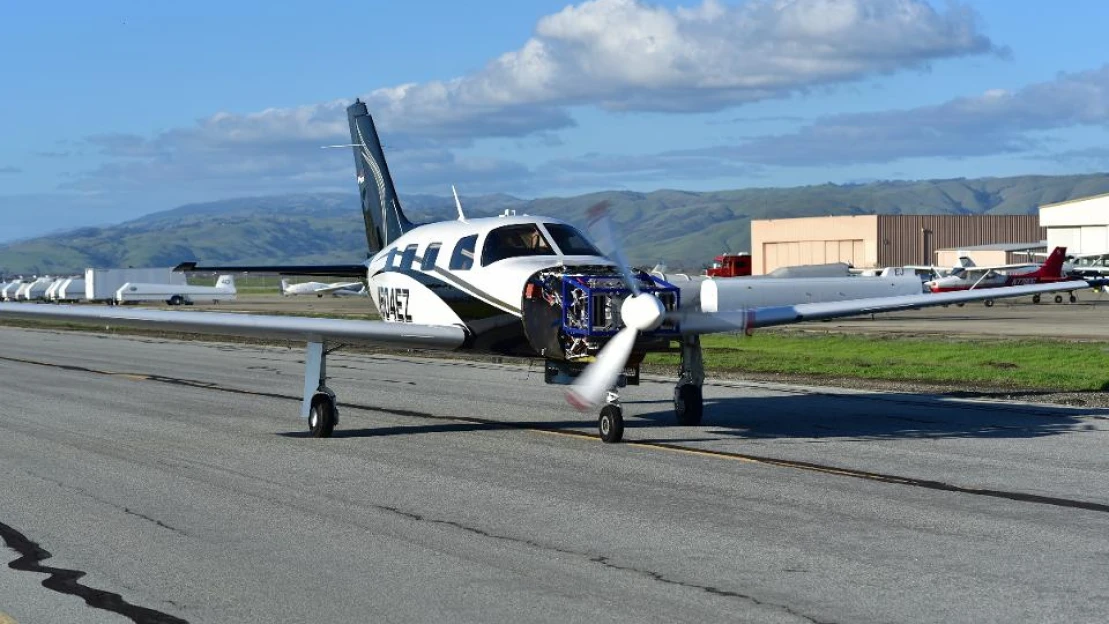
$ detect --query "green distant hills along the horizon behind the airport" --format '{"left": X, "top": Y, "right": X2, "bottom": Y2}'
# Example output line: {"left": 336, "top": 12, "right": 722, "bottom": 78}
{"left": 0, "top": 173, "right": 1109, "bottom": 274}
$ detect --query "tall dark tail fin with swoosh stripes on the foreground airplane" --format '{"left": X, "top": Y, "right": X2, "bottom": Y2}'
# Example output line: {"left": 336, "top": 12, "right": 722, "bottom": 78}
{"left": 347, "top": 100, "right": 413, "bottom": 254}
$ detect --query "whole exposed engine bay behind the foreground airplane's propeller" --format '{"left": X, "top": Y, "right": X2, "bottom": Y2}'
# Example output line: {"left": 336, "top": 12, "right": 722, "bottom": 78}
{"left": 520, "top": 266, "right": 681, "bottom": 362}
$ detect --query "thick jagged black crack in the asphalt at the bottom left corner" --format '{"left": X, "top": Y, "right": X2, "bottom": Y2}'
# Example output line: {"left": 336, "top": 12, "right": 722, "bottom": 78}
{"left": 0, "top": 522, "right": 189, "bottom": 624}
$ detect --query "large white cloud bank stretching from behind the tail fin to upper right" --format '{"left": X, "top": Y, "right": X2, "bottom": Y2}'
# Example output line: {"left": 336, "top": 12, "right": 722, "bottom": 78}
{"left": 60, "top": 0, "right": 996, "bottom": 199}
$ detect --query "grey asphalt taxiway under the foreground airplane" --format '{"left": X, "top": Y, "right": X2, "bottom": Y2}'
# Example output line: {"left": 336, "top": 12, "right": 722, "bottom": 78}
{"left": 0, "top": 328, "right": 1109, "bottom": 624}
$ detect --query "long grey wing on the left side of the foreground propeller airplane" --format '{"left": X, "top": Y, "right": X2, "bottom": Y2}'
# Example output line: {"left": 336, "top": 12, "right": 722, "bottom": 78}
{"left": 0, "top": 304, "right": 466, "bottom": 349}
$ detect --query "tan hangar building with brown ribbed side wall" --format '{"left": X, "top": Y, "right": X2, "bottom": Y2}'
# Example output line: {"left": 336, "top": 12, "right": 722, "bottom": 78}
{"left": 751, "top": 215, "right": 1042, "bottom": 275}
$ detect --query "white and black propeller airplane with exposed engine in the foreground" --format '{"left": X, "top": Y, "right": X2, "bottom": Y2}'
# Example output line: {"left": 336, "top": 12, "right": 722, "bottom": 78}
{"left": 0, "top": 101, "right": 1087, "bottom": 442}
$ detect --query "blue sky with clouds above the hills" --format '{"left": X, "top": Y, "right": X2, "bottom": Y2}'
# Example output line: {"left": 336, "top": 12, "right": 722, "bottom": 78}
{"left": 0, "top": 0, "right": 1109, "bottom": 241}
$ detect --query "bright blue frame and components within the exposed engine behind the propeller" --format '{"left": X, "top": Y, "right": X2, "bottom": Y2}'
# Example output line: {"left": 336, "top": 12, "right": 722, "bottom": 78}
{"left": 561, "top": 273, "right": 681, "bottom": 338}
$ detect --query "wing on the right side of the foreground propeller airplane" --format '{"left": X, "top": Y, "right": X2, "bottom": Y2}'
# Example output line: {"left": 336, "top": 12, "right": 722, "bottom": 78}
{"left": 676, "top": 279, "right": 1091, "bottom": 334}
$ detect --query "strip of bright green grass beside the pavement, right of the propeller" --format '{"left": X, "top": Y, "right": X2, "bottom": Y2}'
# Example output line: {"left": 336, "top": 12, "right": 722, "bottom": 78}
{"left": 645, "top": 333, "right": 1109, "bottom": 391}
